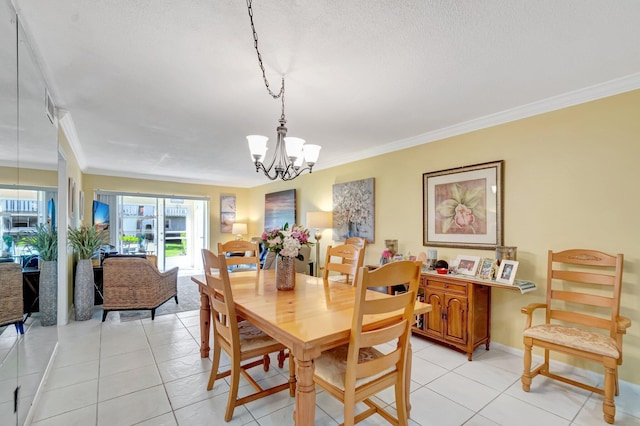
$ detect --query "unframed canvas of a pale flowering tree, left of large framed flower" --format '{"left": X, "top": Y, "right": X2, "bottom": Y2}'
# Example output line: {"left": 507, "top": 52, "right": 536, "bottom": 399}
{"left": 333, "top": 178, "right": 375, "bottom": 244}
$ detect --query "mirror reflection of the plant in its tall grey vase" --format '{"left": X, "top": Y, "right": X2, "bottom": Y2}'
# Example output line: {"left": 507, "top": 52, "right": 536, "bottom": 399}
{"left": 25, "top": 224, "right": 58, "bottom": 326}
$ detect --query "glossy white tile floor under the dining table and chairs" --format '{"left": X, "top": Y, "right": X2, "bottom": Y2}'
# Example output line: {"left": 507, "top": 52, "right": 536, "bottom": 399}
{"left": 28, "top": 311, "right": 640, "bottom": 426}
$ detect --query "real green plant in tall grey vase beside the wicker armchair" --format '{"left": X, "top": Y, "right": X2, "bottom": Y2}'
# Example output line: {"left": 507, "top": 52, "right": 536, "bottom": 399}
{"left": 67, "top": 225, "right": 107, "bottom": 321}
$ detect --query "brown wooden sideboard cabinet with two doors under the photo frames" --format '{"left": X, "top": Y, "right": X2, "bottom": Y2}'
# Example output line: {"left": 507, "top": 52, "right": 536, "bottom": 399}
{"left": 413, "top": 273, "right": 491, "bottom": 361}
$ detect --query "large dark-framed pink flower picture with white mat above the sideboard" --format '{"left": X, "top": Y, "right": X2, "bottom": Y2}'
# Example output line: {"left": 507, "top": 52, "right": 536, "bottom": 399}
{"left": 422, "top": 161, "right": 504, "bottom": 249}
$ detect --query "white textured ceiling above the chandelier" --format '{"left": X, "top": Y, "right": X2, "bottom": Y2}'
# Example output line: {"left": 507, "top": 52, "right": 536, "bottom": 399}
{"left": 14, "top": 0, "right": 640, "bottom": 187}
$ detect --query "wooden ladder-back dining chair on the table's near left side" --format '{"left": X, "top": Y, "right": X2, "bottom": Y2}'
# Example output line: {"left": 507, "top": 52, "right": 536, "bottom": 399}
{"left": 202, "top": 249, "right": 295, "bottom": 422}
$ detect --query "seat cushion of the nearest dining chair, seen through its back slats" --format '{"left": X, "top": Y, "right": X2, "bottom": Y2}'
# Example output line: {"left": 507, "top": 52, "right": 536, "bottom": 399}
{"left": 314, "top": 345, "right": 395, "bottom": 391}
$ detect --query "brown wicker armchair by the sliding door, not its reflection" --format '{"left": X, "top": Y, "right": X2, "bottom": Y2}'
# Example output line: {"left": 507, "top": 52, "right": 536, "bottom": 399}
{"left": 102, "top": 257, "right": 178, "bottom": 321}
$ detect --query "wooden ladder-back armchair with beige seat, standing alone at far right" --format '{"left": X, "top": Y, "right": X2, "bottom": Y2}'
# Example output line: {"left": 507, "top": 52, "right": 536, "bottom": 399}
{"left": 522, "top": 249, "right": 631, "bottom": 423}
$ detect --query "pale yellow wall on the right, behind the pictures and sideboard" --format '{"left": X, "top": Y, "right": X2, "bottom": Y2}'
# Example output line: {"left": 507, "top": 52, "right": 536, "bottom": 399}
{"left": 249, "top": 90, "right": 640, "bottom": 383}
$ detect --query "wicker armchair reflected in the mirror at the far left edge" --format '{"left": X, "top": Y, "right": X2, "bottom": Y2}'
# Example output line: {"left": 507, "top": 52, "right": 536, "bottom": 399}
{"left": 0, "top": 262, "right": 24, "bottom": 334}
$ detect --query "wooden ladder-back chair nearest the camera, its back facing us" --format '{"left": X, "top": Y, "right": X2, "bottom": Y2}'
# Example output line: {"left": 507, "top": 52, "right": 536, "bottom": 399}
{"left": 314, "top": 260, "right": 422, "bottom": 426}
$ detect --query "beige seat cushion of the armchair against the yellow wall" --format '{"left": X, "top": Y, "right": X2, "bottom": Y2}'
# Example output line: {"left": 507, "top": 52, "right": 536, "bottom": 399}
{"left": 523, "top": 324, "right": 620, "bottom": 359}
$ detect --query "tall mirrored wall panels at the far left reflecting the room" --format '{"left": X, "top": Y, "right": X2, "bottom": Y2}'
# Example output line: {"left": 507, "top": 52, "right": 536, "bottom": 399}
{"left": 0, "top": 0, "right": 58, "bottom": 425}
